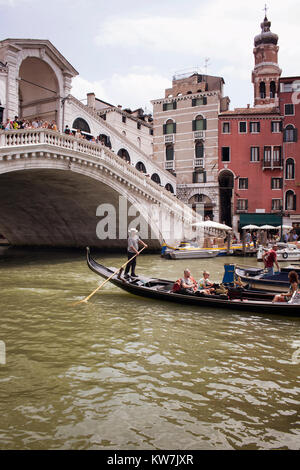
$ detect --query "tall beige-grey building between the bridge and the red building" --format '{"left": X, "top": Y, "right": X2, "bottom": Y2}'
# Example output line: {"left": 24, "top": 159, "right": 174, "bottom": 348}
{"left": 152, "top": 72, "right": 229, "bottom": 221}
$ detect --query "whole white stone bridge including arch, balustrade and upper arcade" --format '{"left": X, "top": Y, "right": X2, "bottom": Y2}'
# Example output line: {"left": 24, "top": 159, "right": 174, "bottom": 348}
{"left": 0, "top": 39, "right": 196, "bottom": 249}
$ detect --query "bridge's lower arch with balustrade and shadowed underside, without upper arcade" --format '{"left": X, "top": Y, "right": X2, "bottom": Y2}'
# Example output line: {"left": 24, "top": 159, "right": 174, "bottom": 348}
{"left": 0, "top": 129, "right": 195, "bottom": 249}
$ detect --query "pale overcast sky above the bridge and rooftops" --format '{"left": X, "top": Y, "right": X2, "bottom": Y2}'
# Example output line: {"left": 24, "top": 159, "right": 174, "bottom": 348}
{"left": 0, "top": 0, "right": 300, "bottom": 111}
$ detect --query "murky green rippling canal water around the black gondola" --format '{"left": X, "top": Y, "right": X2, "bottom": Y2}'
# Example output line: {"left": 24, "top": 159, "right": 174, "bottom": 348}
{"left": 0, "top": 249, "right": 300, "bottom": 450}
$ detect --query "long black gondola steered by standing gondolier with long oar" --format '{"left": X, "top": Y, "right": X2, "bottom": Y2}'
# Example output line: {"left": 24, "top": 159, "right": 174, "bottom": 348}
{"left": 87, "top": 248, "right": 300, "bottom": 316}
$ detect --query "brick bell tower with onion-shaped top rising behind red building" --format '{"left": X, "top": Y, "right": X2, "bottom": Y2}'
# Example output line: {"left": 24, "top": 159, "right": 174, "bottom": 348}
{"left": 252, "top": 15, "right": 281, "bottom": 107}
